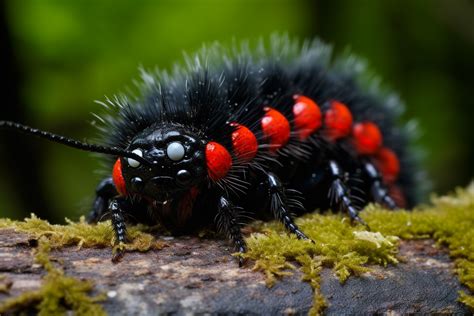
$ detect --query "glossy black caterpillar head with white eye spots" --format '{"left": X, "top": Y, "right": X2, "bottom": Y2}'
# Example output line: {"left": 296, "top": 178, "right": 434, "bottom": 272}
{"left": 114, "top": 124, "right": 207, "bottom": 203}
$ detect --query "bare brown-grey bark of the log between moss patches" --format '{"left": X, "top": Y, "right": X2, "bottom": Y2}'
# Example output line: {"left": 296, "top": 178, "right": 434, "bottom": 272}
{"left": 0, "top": 229, "right": 468, "bottom": 315}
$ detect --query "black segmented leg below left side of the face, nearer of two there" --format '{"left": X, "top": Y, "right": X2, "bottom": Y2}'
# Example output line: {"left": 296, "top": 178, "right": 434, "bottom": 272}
{"left": 109, "top": 197, "right": 128, "bottom": 263}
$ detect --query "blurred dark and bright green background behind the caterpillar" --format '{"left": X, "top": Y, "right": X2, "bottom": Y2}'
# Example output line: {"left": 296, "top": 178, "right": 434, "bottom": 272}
{"left": 0, "top": 0, "right": 474, "bottom": 222}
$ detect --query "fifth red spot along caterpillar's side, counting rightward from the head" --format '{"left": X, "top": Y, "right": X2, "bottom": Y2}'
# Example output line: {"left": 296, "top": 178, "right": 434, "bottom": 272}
{"left": 324, "top": 101, "right": 352, "bottom": 141}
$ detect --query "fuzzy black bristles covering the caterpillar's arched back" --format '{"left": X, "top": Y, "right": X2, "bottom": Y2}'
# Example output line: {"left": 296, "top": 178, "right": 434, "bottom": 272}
{"left": 95, "top": 37, "right": 419, "bottom": 205}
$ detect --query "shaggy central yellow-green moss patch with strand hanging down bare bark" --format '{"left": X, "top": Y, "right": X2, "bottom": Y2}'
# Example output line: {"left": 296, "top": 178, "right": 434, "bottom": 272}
{"left": 244, "top": 214, "right": 398, "bottom": 315}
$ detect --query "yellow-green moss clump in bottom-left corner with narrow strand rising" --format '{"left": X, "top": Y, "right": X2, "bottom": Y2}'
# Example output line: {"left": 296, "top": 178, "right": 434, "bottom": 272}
{"left": 0, "top": 237, "right": 106, "bottom": 315}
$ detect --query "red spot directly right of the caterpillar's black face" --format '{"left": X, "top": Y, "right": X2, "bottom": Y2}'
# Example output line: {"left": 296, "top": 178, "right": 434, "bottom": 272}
{"left": 206, "top": 142, "right": 232, "bottom": 181}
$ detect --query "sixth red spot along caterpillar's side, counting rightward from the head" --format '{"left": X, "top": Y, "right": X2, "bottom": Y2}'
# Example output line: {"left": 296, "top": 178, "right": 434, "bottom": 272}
{"left": 352, "top": 122, "right": 382, "bottom": 155}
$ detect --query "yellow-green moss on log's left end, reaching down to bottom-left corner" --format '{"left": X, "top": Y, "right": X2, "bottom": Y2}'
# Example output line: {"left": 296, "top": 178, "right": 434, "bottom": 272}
{"left": 0, "top": 214, "right": 165, "bottom": 315}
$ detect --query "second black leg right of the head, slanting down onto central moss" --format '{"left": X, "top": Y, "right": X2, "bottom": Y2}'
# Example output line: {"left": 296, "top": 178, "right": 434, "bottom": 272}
{"left": 267, "top": 173, "right": 309, "bottom": 239}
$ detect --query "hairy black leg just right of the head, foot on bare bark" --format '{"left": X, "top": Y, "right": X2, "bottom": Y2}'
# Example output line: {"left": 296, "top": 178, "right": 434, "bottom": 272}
{"left": 215, "top": 196, "right": 247, "bottom": 267}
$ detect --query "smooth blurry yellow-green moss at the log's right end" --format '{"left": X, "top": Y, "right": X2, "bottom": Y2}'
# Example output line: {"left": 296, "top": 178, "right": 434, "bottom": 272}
{"left": 364, "top": 184, "right": 474, "bottom": 309}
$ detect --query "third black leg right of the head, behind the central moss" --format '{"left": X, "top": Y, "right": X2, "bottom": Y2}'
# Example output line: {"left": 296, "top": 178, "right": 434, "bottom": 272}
{"left": 329, "top": 160, "right": 367, "bottom": 226}
